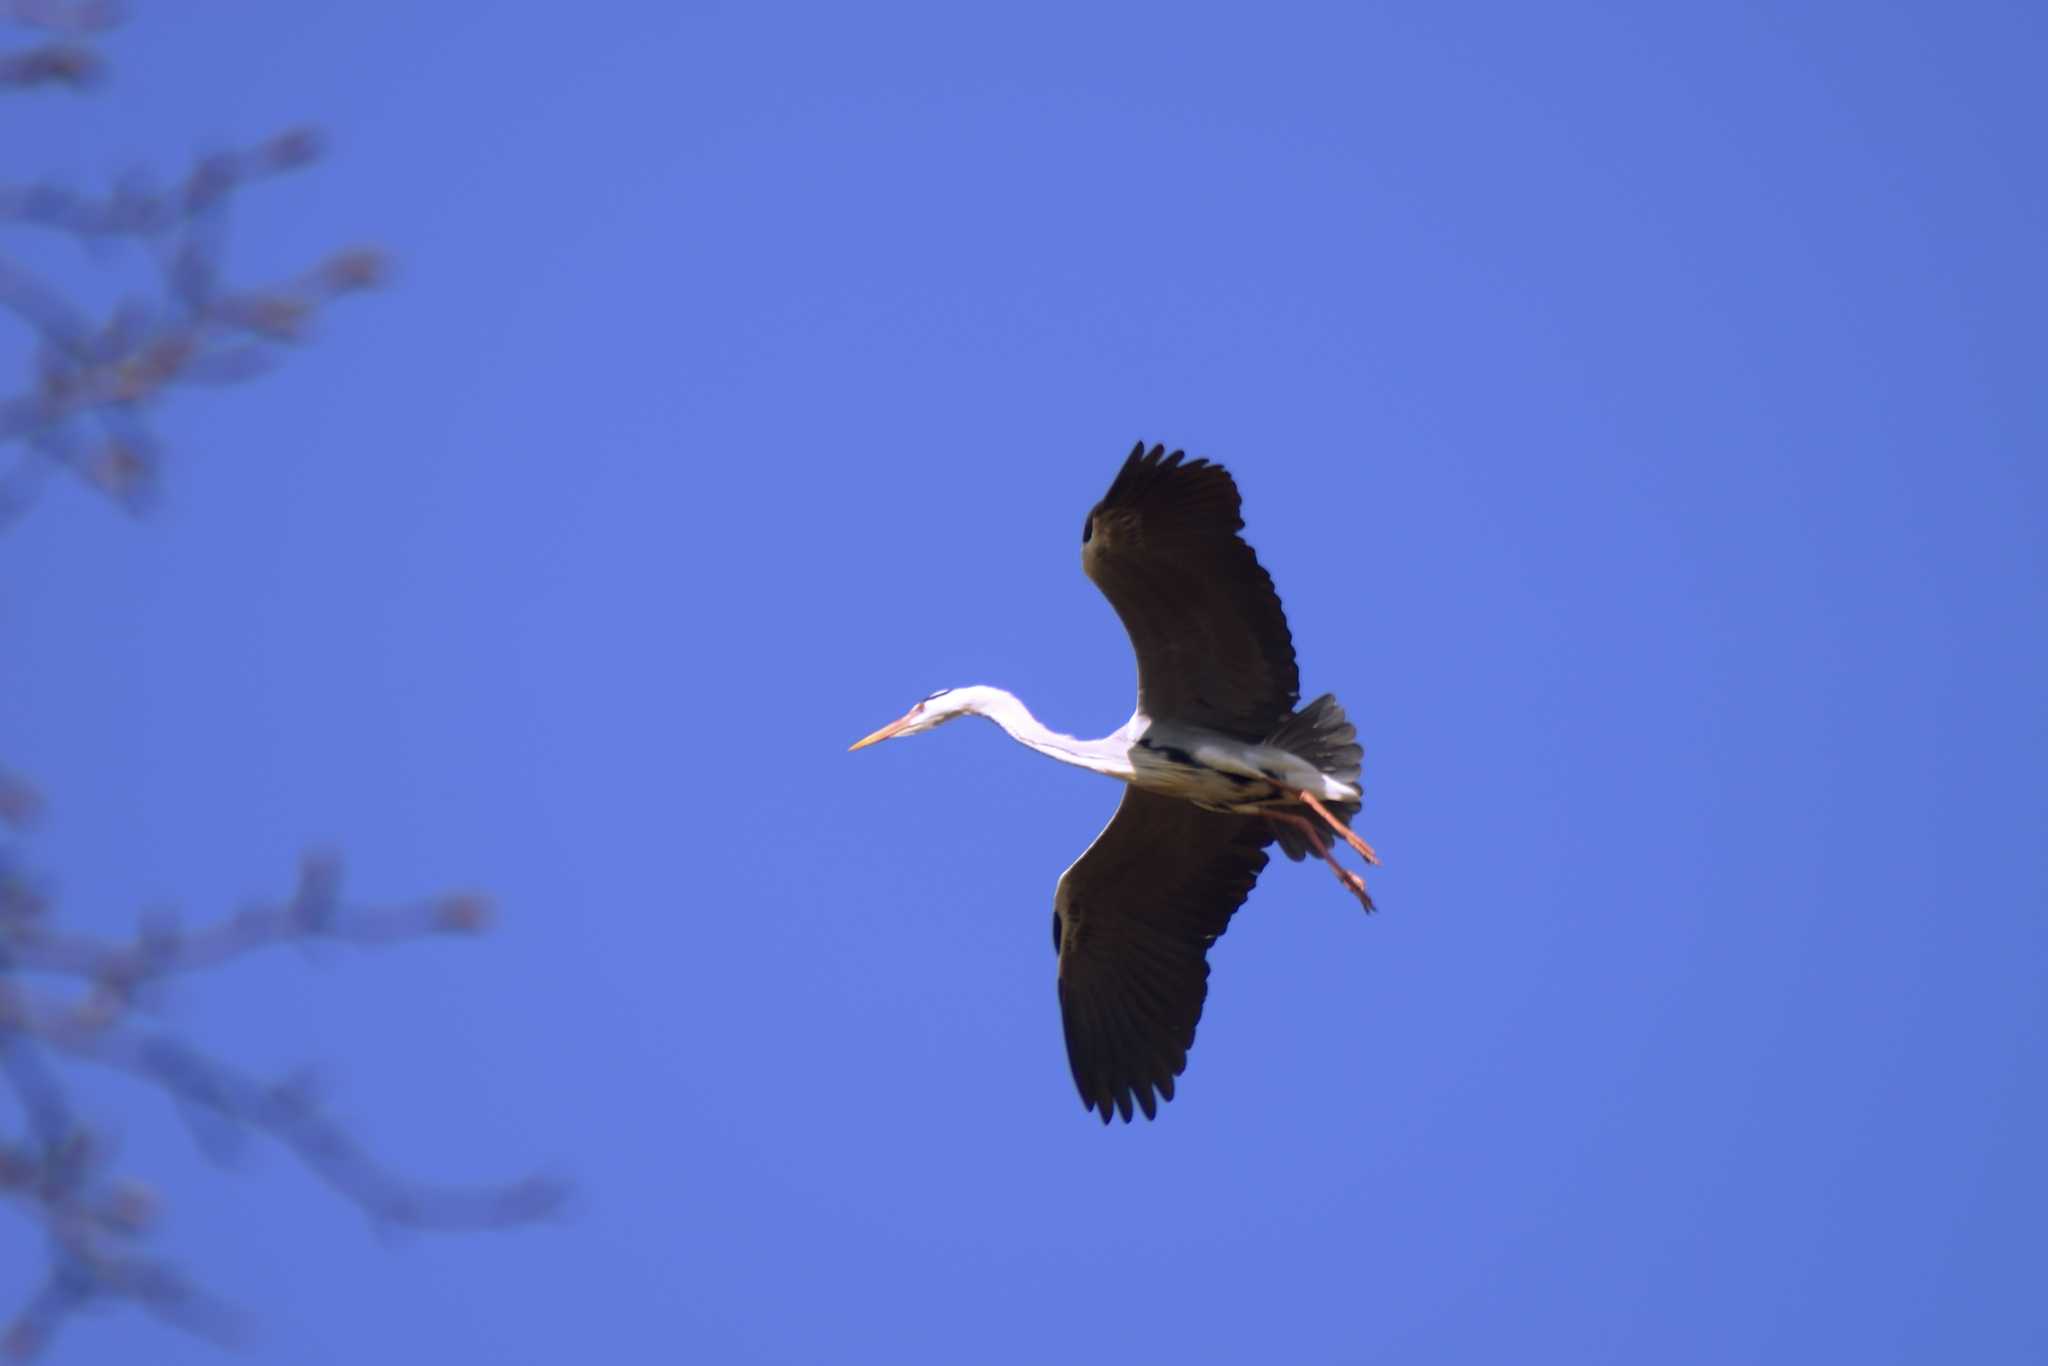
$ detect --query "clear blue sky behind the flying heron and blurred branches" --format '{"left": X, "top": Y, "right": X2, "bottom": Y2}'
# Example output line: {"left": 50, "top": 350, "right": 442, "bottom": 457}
{"left": 0, "top": 4, "right": 2048, "bottom": 1362}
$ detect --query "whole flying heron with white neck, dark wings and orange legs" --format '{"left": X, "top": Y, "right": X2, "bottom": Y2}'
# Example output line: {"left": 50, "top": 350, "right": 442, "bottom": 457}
{"left": 852, "top": 442, "right": 1378, "bottom": 1124}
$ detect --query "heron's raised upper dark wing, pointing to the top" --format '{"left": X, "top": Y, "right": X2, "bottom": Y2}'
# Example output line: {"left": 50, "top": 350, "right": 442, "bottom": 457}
{"left": 1081, "top": 442, "right": 1300, "bottom": 739}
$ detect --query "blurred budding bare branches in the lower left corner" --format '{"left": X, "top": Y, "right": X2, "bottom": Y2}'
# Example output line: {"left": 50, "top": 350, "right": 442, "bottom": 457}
{"left": 0, "top": 852, "right": 567, "bottom": 1356}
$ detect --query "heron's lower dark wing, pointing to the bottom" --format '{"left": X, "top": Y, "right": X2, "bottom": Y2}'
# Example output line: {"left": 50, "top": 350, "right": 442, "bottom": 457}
{"left": 1053, "top": 786, "right": 1272, "bottom": 1124}
